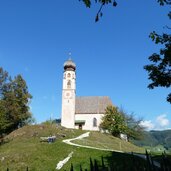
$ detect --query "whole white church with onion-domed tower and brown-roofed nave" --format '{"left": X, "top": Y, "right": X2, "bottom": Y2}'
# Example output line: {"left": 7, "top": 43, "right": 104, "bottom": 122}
{"left": 61, "top": 59, "right": 112, "bottom": 131}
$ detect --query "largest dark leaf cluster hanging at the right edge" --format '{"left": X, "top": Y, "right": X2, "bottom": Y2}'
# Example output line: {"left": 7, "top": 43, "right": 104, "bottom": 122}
{"left": 144, "top": 29, "right": 171, "bottom": 103}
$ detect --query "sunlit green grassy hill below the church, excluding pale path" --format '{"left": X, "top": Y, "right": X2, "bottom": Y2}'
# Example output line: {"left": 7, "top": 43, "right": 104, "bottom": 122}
{"left": 0, "top": 125, "right": 143, "bottom": 171}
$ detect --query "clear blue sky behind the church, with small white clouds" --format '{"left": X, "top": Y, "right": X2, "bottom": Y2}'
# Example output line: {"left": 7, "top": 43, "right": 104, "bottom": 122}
{"left": 0, "top": 0, "right": 171, "bottom": 129}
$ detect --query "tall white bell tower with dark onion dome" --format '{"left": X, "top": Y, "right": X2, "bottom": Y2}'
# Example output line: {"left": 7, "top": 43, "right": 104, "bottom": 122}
{"left": 61, "top": 59, "right": 76, "bottom": 128}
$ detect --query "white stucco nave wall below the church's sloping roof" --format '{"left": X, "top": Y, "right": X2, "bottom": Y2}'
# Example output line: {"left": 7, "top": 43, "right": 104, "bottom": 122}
{"left": 75, "top": 114, "right": 104, "bottom": 131}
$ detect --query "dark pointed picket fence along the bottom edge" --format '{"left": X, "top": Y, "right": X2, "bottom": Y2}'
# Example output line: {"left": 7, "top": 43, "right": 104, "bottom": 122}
{"left": 6, "top": 152, "right": 171, "bottom": 171}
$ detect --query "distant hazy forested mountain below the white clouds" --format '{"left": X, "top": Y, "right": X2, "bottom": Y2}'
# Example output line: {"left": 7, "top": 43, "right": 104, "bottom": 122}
{"left": 132, "top": 130, "right": 171, "bottom": 149}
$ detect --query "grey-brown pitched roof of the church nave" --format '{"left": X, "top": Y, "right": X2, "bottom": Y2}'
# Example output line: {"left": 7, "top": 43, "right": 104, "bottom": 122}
{"left": 75, "top": 96, "right": 112, "bottom": 114}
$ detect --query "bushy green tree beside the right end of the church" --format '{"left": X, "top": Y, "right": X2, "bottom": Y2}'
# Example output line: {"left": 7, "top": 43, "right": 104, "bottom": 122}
{"left": 100, "top": 106, "right": 144, "bottom": 139}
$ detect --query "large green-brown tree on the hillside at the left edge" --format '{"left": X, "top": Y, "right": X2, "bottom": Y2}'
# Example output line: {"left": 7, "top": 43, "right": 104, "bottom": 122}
{"left": 0, "top": 68, "right": 32, "bottom": 136}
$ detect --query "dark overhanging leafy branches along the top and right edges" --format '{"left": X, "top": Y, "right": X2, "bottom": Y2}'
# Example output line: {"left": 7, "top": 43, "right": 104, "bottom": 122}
{"left": 79, "top": 0, "right": 171, "bottom": 103}
